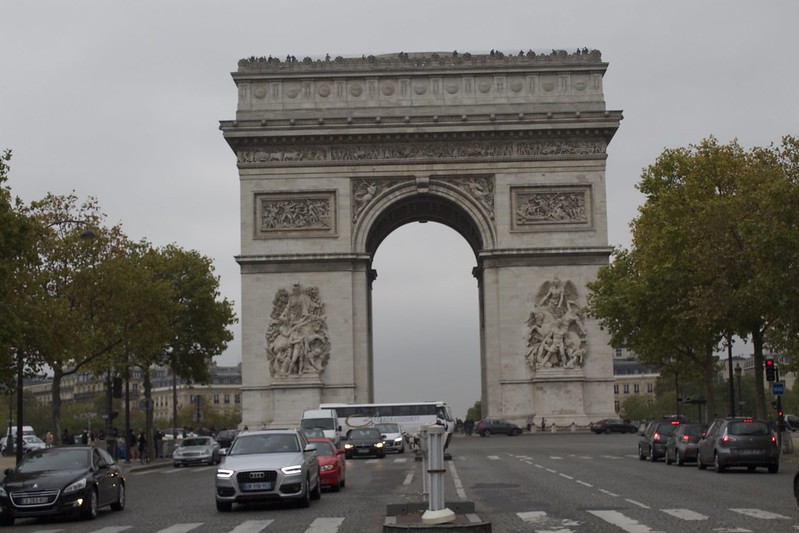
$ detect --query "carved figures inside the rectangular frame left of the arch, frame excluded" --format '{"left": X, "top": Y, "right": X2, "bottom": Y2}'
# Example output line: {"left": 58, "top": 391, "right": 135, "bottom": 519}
{"left": 257, "top": 194, "right": 334, "bottom": 235}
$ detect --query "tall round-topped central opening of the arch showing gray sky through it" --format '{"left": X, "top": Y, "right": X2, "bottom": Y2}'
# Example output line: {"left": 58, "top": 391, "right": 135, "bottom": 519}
{"left": 372, "top": 222, "right": 481, "bottom": 418}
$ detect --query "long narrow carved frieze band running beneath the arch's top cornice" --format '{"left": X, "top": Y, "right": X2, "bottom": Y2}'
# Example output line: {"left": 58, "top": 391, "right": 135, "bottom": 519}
{"left": 237, "top": 140, "right": 607, "bottom": 166}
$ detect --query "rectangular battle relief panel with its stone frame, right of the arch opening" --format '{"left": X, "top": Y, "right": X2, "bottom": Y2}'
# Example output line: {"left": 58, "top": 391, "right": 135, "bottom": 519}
{"left": 511, "top": 185, "right": 594, "bottom": 232}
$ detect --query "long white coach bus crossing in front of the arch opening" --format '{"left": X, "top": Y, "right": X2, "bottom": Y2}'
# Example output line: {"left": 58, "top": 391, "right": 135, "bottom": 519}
{"left": 319, "top": 402, "right": 455, "bottom": 447}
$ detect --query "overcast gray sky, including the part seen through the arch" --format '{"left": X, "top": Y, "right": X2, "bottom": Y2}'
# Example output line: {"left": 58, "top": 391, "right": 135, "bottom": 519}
{"left": 0, "top": 0, "right": 799, "bottom": 416}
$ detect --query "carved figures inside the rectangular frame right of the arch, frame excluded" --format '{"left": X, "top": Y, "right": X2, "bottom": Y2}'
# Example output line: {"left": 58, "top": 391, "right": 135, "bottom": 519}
{"left": 514, "top": 189, "right": 589, "bottom": 226}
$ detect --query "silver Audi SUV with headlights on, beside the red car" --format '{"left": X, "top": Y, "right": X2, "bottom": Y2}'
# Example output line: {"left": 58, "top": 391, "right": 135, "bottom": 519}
{"left": 216, "top": 429, "right": 322, "bottom": 512}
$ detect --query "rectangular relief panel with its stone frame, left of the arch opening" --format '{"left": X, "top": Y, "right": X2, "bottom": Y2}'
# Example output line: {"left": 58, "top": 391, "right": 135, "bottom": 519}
{"left": 255, "top": 191, "right": 336, "bottom": 239}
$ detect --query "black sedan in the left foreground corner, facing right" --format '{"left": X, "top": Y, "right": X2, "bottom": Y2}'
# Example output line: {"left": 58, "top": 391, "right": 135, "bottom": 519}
{"left": 0, "top": 446, "right": 125, "bottom": 526}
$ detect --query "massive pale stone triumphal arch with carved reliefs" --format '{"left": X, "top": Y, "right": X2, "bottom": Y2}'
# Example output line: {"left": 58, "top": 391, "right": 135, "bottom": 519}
{"left": 221, "top": 49, "right": 622, "bottom": 427}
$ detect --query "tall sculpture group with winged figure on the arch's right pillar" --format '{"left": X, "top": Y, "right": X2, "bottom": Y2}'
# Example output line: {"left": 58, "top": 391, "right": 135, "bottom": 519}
{"left": 525, "top": 276, "right": 587, "bottom": 371}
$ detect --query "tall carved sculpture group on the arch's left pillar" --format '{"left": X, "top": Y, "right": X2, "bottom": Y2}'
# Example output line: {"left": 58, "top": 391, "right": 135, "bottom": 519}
{"left": 266, "top": 283, "right": 330, "bottom": 378}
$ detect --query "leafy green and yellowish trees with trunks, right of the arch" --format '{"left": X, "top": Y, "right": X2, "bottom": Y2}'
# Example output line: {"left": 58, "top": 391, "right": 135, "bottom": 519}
{"left": 588, "top": 137, "right": 799, "bottom": 416}
